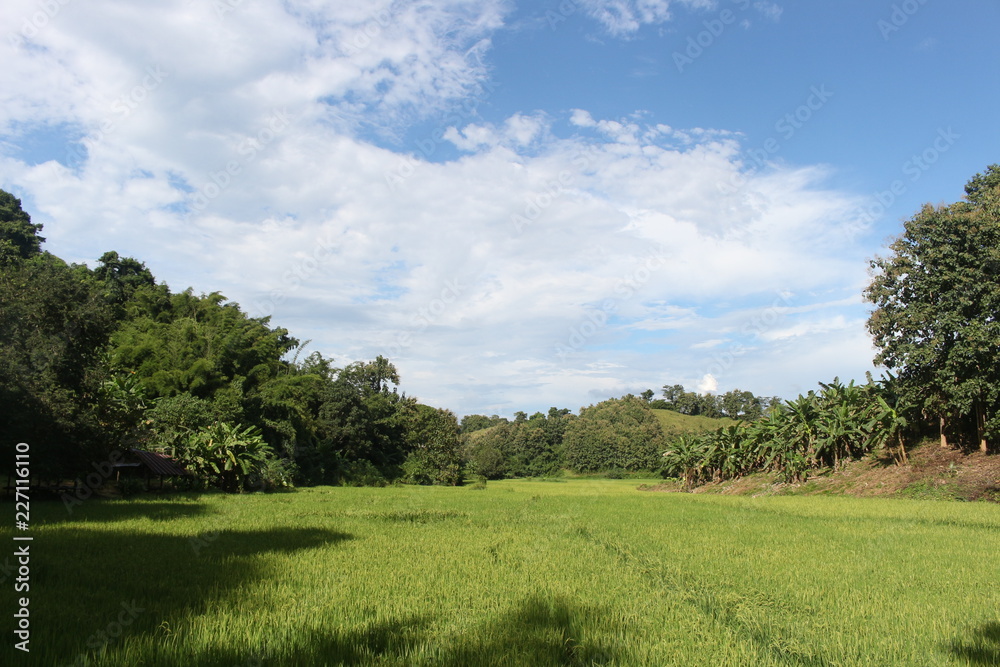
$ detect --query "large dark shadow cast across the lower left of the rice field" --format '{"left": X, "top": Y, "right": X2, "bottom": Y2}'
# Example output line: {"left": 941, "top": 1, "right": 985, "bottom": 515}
{"left": 0, "top": 528, "right": 352, "bottom": 665}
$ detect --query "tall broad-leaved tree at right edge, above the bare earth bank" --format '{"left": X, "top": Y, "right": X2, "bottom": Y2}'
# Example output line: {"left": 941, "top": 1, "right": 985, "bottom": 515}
{"left": 865, "top": 165, "right": 1000, "bottom": 451}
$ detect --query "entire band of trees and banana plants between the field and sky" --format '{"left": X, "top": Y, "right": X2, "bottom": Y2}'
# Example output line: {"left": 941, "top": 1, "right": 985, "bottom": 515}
{"left": 0, "top": 165, "right": 1000, "bottom": 491}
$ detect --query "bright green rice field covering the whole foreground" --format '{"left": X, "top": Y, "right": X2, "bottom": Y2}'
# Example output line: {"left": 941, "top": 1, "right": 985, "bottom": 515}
{"left": 0, "top": 480, "right": 1000, "bottom": 667}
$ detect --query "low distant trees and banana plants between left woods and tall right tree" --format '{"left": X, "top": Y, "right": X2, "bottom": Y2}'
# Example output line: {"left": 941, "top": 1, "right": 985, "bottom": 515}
{"left": 462, "top": 376, "right": 927, "bottom": 488}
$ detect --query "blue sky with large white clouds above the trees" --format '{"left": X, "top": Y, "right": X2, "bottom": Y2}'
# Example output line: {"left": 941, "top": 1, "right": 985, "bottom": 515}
{"left": 0, "top": 0, "right": 1000, "bottom": 416}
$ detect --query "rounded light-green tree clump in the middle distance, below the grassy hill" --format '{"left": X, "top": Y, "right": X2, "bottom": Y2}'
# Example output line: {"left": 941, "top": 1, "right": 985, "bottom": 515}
{"left": 564, "top": 395, "right": 664, "bottom": 472}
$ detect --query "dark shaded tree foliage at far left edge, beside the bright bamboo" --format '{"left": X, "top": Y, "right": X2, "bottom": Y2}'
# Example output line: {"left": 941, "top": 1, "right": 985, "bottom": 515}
{"left": 0, "top": 253, "right": 117, "bottom": 476}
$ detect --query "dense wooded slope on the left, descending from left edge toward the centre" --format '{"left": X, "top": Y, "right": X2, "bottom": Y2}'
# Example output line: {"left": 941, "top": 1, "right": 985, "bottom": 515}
{"left": 0, "top": 191, "right": 461, "bottom": 490}
